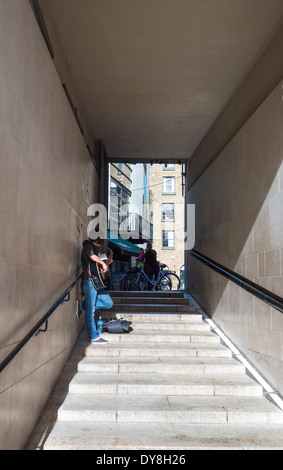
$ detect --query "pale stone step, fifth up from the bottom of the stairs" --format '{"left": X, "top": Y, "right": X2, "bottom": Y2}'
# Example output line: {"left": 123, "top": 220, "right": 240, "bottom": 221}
{"left": 85, "top": 335, "right": 232, "bottom": 358}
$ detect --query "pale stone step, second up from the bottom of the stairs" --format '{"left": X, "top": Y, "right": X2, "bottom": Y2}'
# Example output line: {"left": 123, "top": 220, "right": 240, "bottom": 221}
{"left": 58, "top": 395, "right": 283, "bottom": 424}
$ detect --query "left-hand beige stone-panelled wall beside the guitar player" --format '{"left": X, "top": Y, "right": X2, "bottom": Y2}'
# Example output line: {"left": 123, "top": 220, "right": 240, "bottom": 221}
{"left": 0, "top": 0, "right": 97, "bottom": 449}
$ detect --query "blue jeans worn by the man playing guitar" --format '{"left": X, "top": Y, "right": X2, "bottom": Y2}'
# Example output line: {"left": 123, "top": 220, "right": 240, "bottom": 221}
{"left": 82, "top": 280, "right": 113, "bottom": 341}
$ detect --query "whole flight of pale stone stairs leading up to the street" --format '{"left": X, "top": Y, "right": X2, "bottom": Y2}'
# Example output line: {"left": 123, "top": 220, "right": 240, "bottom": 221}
{"left": 40, "top": 292, "right": 283, "bottom": 450}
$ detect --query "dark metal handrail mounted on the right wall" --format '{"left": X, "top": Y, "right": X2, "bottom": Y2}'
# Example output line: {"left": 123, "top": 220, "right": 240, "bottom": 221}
{"left": 191, "top": 250, "right": 283, "bottom": 313}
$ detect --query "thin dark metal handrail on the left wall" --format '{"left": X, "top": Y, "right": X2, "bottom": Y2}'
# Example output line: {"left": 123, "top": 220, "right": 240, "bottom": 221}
{"left": 0, "top": 273, "right": 82, "bottom": 373}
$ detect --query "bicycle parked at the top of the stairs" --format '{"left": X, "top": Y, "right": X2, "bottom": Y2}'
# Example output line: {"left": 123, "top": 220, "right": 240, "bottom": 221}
{"left": 120, "top": 267, "right": 180, "bottom": 291}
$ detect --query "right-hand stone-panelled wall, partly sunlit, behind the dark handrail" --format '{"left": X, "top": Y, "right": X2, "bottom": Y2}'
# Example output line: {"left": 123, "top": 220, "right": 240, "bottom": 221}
{"left": 188, "top": 79, "right": 283, "bottom": 394}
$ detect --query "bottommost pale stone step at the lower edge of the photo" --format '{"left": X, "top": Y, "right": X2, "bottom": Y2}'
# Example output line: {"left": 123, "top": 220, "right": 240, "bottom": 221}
{"left": 44, "top": 421, "right": 283, "bottom": 451}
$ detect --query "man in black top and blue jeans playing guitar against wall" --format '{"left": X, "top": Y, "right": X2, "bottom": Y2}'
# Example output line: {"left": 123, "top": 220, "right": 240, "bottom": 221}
{"left": 81, "top": 237, "right": 113, "bottom": 344}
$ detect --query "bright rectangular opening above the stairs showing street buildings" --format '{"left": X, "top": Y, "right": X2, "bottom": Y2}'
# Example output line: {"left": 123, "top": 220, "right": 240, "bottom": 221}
{"left": 107, "top": 161, "right": 186, "bottom": 290}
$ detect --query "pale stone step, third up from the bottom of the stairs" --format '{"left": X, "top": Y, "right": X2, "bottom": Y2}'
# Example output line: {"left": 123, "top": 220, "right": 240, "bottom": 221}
{"left": 69, "top": 372, "right": 262, "bottom": 396}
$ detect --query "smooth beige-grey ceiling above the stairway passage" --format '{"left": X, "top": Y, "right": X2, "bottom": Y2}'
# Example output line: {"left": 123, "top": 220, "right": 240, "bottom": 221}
{"left": 42, "top": 0, "right": 283, "bottom": 159}
